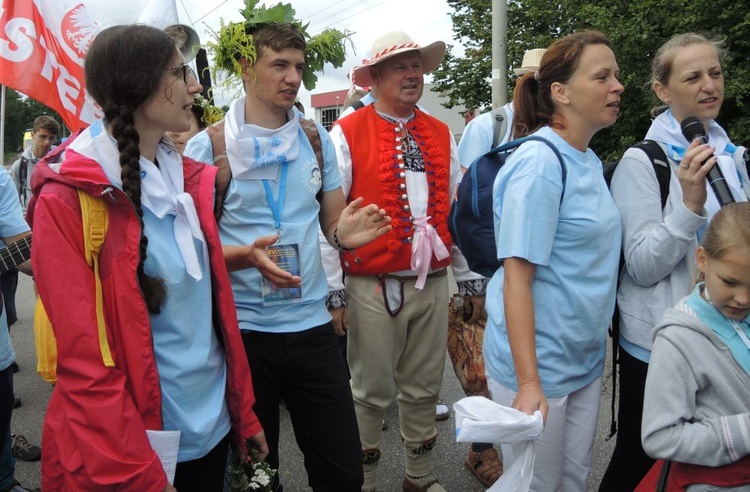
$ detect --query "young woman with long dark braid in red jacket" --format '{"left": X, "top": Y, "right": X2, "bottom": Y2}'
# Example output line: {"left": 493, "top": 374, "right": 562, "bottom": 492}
{"left": 30, "top": 25, "right": 267, "bottom": 492}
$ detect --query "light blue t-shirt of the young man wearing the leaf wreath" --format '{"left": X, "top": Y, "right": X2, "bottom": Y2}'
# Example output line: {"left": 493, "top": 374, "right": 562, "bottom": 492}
{"left": 185, "top": 121, "right": 341, "bottom": 333}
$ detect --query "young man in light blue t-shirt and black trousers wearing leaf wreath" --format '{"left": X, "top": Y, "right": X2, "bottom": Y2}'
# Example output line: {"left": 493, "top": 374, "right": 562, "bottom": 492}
{"left": 185, "top": 13, "right": 390, "bottom": 492}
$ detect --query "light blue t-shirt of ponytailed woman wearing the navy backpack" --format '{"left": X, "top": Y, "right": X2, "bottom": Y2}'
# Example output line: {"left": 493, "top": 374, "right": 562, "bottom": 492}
{"left": 483, "top": 127, "right": 622, "bottom": 398}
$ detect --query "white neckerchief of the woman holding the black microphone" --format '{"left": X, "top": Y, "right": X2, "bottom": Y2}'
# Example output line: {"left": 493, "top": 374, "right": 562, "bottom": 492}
{"left": 646, "top": 109, "right": 744, "bottom": 219}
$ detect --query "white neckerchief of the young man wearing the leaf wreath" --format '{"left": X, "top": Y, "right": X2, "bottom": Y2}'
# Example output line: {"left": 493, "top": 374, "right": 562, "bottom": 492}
{"left": 224, "top": 97, "right": 299, "bottom": 180}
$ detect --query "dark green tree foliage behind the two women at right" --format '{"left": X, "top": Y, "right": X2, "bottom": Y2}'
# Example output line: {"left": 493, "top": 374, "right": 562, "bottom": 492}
{"left": 433, "top": 0, "right": 750, "bottom": 160}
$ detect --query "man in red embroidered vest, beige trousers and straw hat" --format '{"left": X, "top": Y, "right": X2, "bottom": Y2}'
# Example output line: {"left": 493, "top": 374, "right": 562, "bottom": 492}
{"left": 331, "top": 32, "right": 484, "bottom": 492}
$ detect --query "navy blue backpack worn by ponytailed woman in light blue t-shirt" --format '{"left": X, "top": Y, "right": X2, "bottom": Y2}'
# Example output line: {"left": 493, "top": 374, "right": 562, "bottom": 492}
{"left": 448, "top": 135, "right": 567, "bottom": 277}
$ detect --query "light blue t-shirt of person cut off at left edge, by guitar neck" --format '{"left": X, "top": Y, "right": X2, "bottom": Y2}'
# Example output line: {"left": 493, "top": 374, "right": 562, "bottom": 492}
{"left": 0, "top": 168, "right": 29, "bottom": 371}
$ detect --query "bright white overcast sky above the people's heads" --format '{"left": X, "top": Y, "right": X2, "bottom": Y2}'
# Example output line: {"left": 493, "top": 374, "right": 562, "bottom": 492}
{"left": 82, "top": 0, "right": 458, "bottom": 108}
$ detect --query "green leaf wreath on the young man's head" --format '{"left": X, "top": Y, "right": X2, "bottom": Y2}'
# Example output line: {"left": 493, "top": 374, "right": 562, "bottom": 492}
{"left": 206, "top": 0, "right": 351, "bottom": 94}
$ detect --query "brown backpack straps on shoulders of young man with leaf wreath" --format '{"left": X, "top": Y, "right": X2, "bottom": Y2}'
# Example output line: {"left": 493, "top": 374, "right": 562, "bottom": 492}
{"left": 212, "top": 118, "right": 324, "bottom": 222}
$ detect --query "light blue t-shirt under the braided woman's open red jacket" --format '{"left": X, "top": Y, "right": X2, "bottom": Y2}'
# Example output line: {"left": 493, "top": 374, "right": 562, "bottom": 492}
{"left": 143, "top": 207, "right": 231, "bottom": 461}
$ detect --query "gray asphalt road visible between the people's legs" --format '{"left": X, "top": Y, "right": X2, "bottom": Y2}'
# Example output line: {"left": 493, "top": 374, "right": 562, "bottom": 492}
{"left": 11, "top": 274, "right": 613, "bottom": 492}
